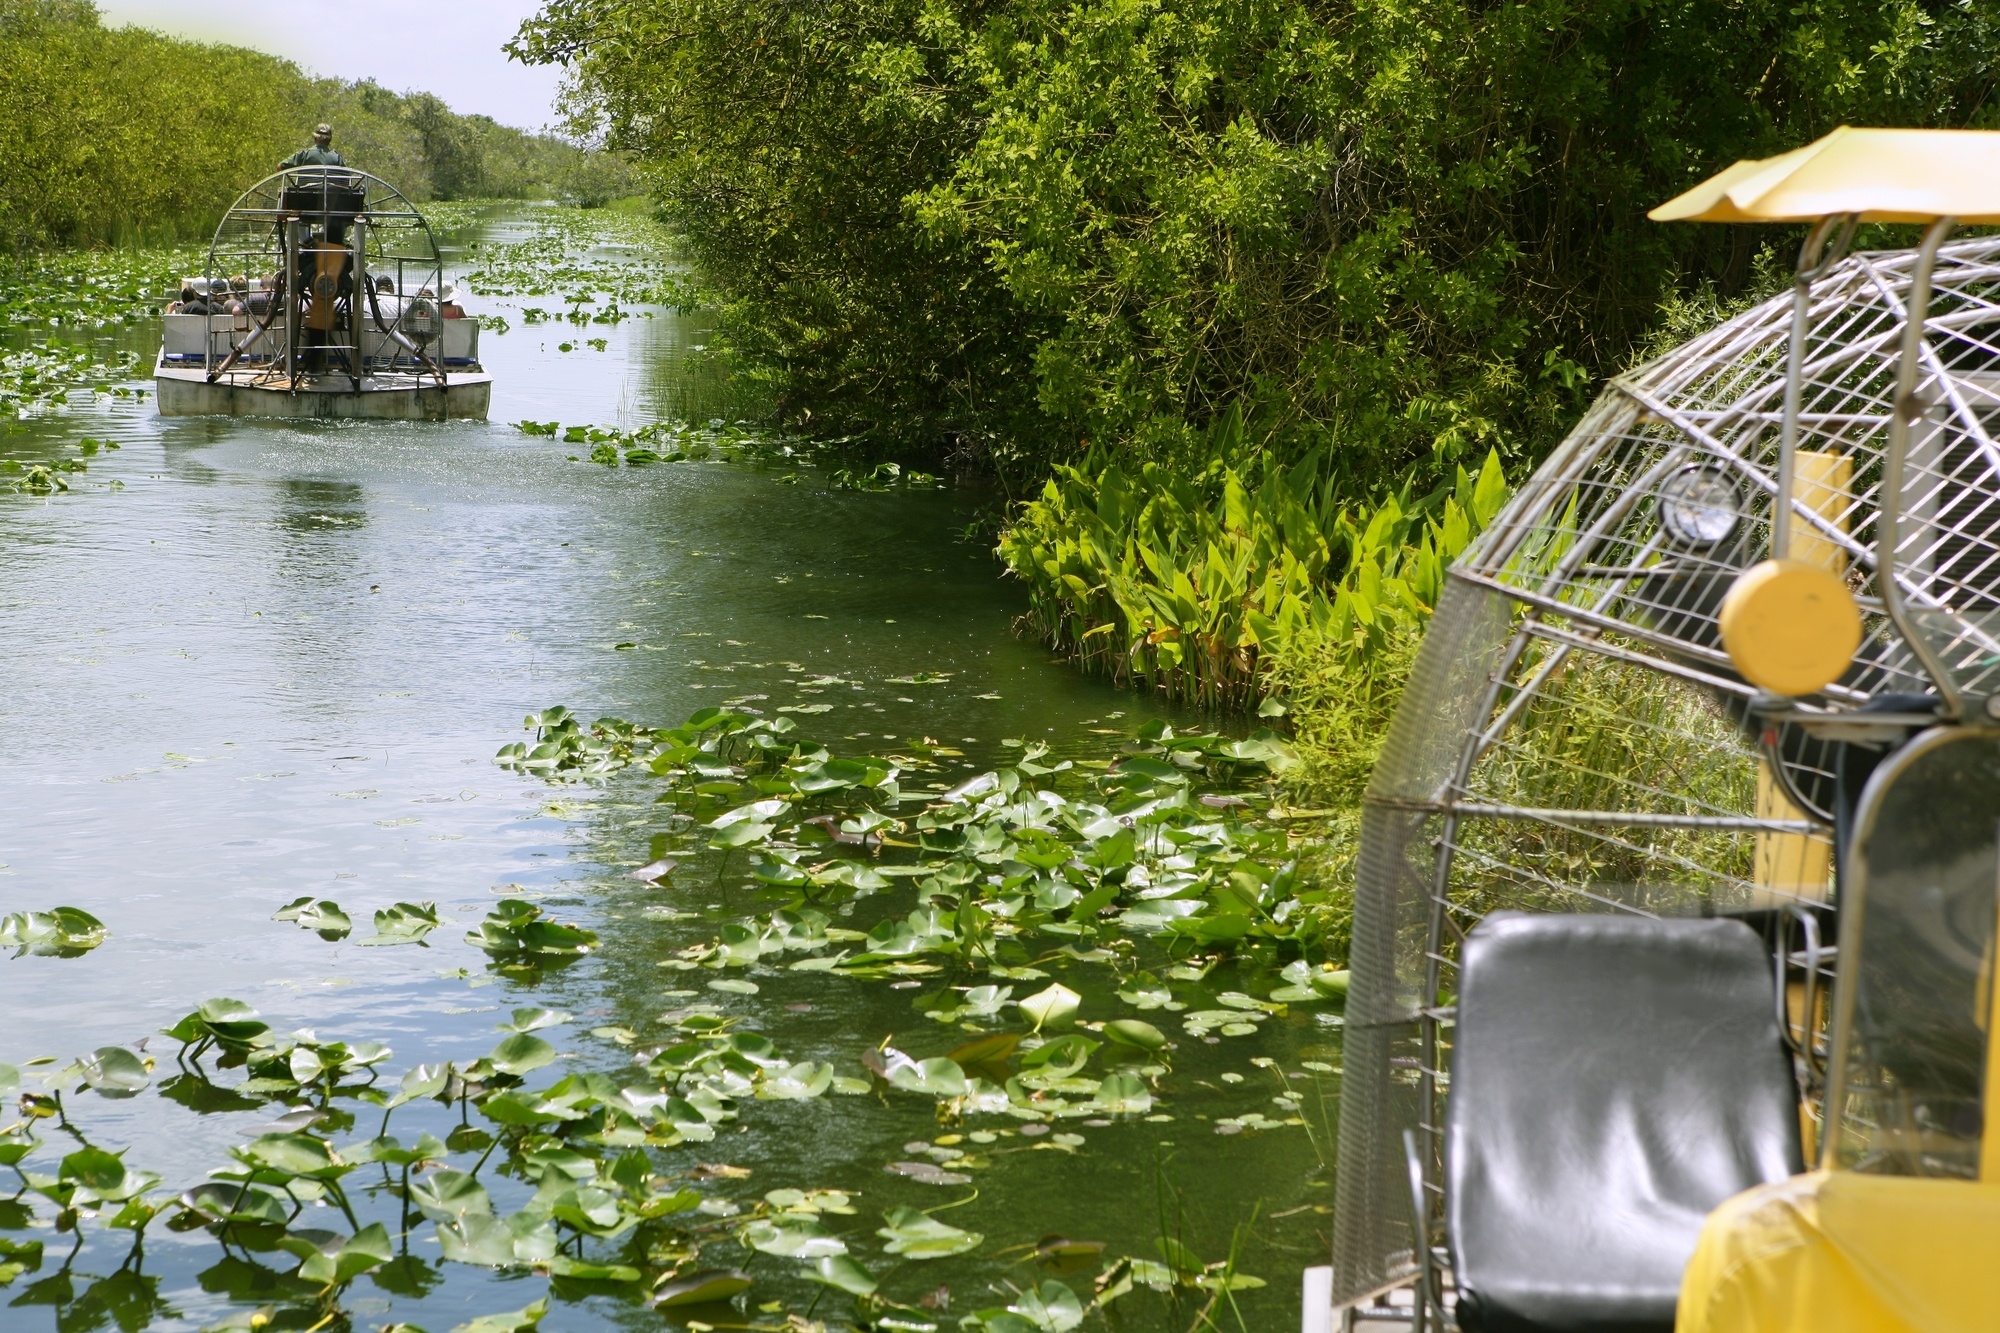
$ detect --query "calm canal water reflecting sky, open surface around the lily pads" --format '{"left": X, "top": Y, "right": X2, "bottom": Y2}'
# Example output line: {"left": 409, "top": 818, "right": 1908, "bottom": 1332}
{"left": 0, "top": 216, "right": 1338, "bottom": 1333}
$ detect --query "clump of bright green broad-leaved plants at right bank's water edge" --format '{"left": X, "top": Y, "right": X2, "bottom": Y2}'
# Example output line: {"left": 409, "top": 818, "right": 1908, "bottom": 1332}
{"left": 1000, "top": 440, "right": 1506, "bottom": 709}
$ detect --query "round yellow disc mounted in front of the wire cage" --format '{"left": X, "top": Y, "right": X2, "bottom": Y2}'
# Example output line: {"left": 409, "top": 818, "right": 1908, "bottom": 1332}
{"left": 1720, "top": 560, "right": 1862, "bottom": 699}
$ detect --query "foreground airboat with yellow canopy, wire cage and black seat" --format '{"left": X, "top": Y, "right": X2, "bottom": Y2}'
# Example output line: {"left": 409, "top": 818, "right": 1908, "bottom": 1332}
{"left": 1306, "top": 130, "right": 2000, "bottom": 1333}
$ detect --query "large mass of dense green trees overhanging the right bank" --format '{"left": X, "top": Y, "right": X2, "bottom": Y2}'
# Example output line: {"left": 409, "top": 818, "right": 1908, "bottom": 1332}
{"left": 516, "top": 0, "right": 2000, "bottom": 478}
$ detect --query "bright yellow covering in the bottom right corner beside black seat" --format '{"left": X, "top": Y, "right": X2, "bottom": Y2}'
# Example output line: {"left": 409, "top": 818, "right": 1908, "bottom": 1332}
{"left": 1674, "top": 1171, "right": 2000, "bottom": 1333}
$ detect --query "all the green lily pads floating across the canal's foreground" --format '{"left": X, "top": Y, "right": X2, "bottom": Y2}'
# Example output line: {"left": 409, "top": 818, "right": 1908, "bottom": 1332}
{"left": 0, "top": 700, "right": 1332, "bottom": 1333}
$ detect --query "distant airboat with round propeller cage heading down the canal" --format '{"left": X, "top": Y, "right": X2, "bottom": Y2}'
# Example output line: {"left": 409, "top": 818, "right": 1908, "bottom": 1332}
{"left": 154, "top": 166, "right": 492, "bottom": 420}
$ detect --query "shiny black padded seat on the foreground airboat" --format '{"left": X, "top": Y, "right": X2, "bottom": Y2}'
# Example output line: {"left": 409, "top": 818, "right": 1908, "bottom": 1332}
{"left": 1444, "top": 913, "right": 1802, "bottom": 1333}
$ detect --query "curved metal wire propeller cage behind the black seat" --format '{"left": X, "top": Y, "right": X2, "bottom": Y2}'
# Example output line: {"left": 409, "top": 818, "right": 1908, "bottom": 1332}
{"left": 1334, "top": 238, "right": 2000, "bottom": 1303}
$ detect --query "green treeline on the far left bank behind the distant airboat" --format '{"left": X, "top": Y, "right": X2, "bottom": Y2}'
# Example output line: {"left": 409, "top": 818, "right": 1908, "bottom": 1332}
{"left": 0, "top": 0, "right": 600, "bottom": 250}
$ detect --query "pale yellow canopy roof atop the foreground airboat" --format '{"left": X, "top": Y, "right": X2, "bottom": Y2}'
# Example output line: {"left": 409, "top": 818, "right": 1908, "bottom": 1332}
{"left": 1646, "top": 126, "right": 2000, "bottom": 222}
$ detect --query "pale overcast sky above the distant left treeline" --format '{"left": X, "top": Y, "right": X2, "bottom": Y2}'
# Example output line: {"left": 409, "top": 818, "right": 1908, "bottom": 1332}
{"left": 98, "top": 0, "right": 560, "bottom": 130}
